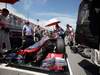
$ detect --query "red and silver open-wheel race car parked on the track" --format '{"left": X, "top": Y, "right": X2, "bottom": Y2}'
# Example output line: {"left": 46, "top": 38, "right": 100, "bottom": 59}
{"left": 2, "top": 32, "right": 69, "bottom": 73}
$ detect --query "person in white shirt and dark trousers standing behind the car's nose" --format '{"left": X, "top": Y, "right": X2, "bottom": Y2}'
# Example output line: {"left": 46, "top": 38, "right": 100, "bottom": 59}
{"left": 22, "top": 22, "right": 34, "bottom": 49}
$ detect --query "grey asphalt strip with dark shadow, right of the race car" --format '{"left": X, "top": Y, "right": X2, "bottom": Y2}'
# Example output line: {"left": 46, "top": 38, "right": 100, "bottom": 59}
{"left": 65, "top": 42, "right": 100, "bottom": 75}
